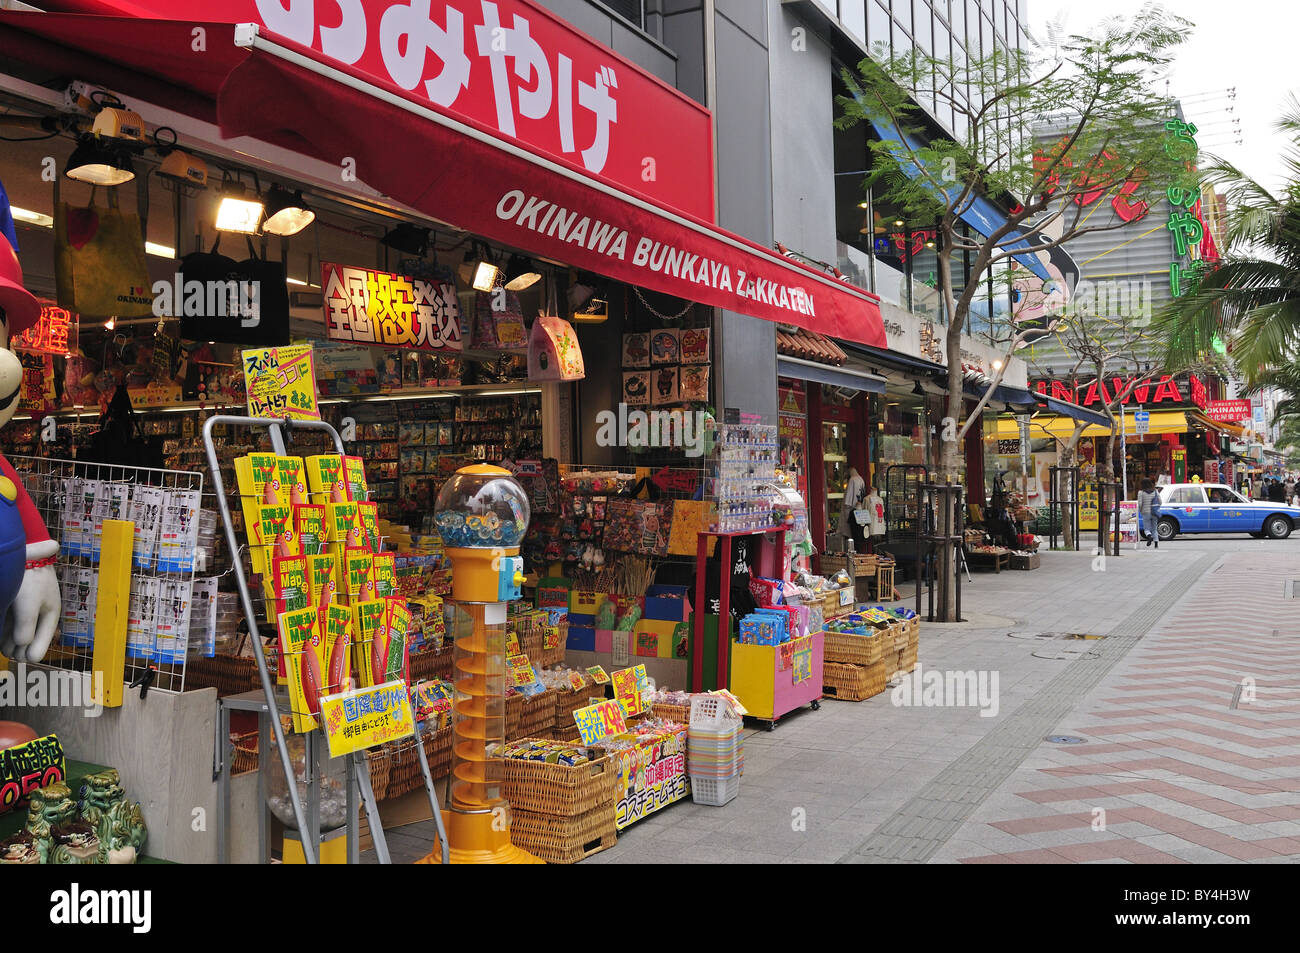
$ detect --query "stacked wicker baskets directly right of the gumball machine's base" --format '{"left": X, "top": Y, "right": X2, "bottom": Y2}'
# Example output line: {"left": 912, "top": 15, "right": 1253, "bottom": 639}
{"left": 501, "top": 758, "right": 618, "bottom": 863}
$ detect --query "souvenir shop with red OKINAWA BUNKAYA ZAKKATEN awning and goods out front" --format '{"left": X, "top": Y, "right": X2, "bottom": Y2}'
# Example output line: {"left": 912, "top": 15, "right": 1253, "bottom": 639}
{"left": 0, "top": 1, "right": 918, "bottom": 862}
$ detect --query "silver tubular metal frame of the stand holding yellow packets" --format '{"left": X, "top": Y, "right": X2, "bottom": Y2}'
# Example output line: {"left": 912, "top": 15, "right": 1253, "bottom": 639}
{"left": 203, "top": 416, "right": 450, "bottom": 863}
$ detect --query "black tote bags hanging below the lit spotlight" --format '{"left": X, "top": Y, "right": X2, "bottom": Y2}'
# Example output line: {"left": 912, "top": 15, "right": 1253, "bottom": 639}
{"left": 175, "top": 231, "right": 289, "bottom": 347}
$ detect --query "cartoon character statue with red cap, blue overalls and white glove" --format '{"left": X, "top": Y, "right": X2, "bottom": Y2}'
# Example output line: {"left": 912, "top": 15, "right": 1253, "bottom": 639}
{"left": 0, "top": 235, "right": 60, "bottom": 662}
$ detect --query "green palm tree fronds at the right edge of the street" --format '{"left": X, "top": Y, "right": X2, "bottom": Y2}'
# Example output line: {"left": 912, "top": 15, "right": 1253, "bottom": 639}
{"left": 1154, "top": 94, "right": 1300, "bottom": 377}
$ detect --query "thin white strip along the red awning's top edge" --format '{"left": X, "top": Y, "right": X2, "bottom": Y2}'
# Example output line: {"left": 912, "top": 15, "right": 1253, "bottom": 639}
{"left": 234, "top": 23, "right": 879, "bottom": 307}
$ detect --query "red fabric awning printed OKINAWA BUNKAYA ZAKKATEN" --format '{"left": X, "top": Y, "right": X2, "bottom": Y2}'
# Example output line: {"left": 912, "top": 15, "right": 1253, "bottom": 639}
{"left": 0, "top": 13, "right": 887, "bottom": 347}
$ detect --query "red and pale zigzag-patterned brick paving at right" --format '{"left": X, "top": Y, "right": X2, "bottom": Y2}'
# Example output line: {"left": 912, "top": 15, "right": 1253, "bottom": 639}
{"left": 935, "top": 553, "right": 1300, "bottom": 863}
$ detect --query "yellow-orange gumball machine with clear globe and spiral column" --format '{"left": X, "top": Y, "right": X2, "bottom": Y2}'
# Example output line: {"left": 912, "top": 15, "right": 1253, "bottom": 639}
{"left": 425, "top": 464, "right": 541, "bottom": 863}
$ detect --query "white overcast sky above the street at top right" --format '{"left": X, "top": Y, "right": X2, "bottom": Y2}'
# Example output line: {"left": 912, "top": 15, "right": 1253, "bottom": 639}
{"left": 1028, "top": 0, "right": 1300, "bottom": 189}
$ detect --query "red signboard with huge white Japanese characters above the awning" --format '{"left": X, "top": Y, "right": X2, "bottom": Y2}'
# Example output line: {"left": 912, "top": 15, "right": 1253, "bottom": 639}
{"left": 40, "top": 0, "right": 714, "bottom": 222}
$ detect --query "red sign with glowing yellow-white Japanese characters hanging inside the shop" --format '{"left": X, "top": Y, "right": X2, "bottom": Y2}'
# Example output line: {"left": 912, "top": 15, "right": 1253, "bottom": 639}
{"left": 321, "top": 261, "right": 460, "bottom": 351}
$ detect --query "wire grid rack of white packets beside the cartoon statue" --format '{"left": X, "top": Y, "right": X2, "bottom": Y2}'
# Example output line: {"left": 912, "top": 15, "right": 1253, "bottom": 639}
{"left": 9, "top": 456, "right": 208, "bottom": 692}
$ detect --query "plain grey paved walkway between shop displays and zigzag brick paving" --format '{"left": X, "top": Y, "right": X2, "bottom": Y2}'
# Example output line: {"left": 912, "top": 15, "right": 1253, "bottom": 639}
{"left": 589, "top": 547, "right": 1216, "bottom": 863}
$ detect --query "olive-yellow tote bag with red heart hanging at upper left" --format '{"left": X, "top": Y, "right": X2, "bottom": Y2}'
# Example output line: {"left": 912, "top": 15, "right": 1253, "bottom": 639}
{"left": 55, "top": 178, "right": 153, "bottom": 317}
